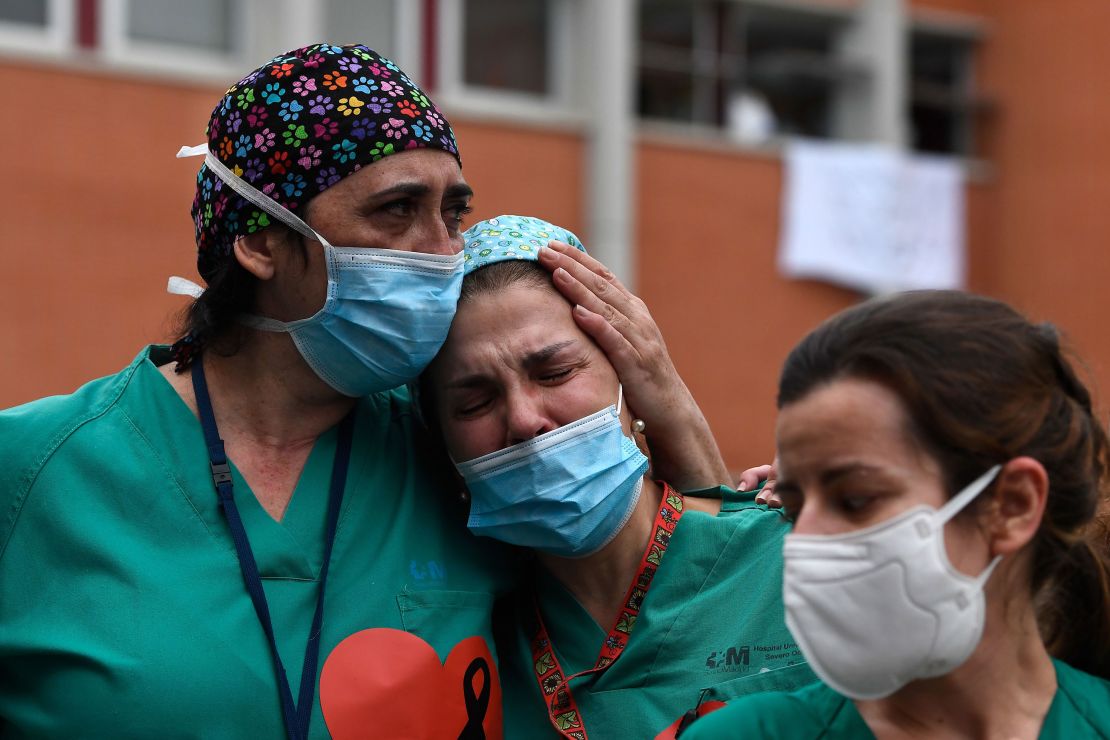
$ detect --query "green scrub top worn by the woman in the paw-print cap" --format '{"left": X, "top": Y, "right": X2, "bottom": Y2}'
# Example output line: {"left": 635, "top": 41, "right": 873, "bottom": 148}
{"left": 0, "top": 347, "right": 513, "bottom": 738}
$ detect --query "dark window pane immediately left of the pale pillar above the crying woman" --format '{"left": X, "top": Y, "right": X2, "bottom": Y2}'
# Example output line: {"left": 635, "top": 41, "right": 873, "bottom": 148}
{"left": 463, "top": 0, "right": 552, "bottom": 94}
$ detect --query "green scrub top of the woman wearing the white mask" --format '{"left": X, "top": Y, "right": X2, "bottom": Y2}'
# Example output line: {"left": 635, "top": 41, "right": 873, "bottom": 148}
{"left": 682, "top": 660, "right": 1110, "bottom": 740}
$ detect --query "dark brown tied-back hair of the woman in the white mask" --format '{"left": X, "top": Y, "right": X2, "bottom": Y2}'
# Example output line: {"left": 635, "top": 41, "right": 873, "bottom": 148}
{"left": 778, "top": 291, "right": 1110, "bottom": 678}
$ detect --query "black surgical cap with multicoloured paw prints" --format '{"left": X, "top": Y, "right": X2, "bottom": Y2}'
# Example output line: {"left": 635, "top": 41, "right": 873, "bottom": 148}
{"left": 192, "top": 43, "right": 462, "bottom": 280}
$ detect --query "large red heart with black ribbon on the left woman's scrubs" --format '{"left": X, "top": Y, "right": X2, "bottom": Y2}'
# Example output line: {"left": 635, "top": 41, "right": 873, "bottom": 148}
{"left": 320, "top": 628, "right": 502, "bottom": 740}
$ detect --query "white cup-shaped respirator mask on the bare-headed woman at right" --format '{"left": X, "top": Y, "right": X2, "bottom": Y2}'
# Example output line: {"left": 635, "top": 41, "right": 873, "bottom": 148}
{"left": 783, "top": 465, "right": 1001, "bottom": 699}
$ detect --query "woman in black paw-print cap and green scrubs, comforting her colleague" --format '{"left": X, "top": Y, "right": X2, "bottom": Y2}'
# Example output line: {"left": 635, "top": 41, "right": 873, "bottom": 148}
{"left": 0, "top": 43, "right": 723, "bottom": 738}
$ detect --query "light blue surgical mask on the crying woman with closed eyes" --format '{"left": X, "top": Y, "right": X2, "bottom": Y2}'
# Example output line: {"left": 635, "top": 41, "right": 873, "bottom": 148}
{"left": 455, "top": 389, "right": 647, "bottom": 558}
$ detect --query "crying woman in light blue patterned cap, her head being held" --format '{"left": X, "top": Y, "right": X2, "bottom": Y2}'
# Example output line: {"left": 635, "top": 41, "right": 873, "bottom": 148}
{"left": 421, "top": 216, "right": 814, "bottom": 739}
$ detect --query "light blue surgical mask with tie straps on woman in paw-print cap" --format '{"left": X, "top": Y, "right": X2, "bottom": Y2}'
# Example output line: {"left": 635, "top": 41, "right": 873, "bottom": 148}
{"left": 172, "top": 145, "right": 463, "bottom": 397}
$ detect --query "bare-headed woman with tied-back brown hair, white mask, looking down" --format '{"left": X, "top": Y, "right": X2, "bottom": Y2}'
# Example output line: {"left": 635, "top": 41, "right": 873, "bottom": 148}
{"left": 680, "top": 292, "right": 1110, "bottom": 740}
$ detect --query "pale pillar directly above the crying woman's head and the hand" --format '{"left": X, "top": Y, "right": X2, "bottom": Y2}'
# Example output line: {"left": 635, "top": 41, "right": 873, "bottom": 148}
{"left": 582, "top": 0, "right": 637, "bottom": 287}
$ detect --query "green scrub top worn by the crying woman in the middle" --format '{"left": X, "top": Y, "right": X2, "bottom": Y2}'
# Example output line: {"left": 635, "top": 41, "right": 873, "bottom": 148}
{"left": 498, "top": 487, "right": 817, "bottom": 740}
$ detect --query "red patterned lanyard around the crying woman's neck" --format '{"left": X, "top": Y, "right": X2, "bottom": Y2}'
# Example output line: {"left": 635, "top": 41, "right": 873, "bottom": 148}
{"left": 532, "top": 484, "right": 684, "bottom": 740}
